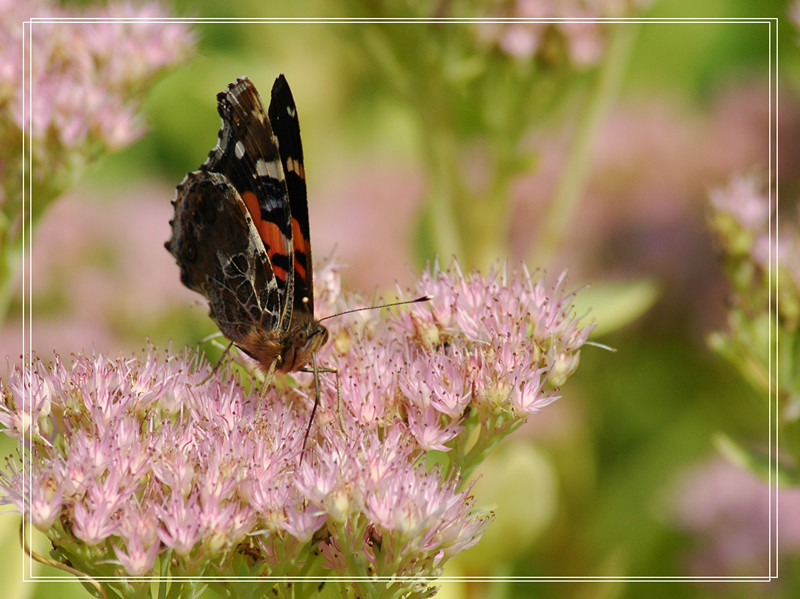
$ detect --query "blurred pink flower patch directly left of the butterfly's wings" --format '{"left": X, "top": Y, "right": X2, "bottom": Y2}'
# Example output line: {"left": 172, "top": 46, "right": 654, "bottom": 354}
{"left": 0, "top": 184, "right": 192, "bottom": 355}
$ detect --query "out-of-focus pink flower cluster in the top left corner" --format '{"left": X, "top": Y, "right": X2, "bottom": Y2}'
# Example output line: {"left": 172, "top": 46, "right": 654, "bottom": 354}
{"left": 0, "top": 0, "right": 194, "bottom": 202}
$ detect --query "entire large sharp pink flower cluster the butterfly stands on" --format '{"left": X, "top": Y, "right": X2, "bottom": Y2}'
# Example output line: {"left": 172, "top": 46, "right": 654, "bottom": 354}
{"left": 0, "top": 267, "right": 591, "bottom": 596}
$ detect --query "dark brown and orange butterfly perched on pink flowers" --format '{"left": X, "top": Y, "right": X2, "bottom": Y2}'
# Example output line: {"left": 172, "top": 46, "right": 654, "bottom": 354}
{"left": 164, "top": 75, "right": 328, "bottom": 396}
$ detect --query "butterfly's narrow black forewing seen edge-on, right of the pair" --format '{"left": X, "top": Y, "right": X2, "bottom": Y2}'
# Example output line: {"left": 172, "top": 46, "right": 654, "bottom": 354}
{"left": 268, "top": 75, "right": 314, "bottom": 319}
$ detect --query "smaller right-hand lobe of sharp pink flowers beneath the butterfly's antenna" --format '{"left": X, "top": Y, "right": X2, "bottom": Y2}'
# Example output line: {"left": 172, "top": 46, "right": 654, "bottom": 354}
{"left": 322, "top": 264, "right": 593, "bottom": 472}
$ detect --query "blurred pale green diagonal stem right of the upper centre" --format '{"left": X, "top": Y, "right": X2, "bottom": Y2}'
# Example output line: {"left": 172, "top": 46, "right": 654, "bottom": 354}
{"left": 528, "top": 23, "right": 639, "bottom": 267}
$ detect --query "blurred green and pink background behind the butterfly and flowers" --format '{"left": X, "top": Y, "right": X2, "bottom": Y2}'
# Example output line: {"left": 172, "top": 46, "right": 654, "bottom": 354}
{"left": 0, "top": 0, "right": 800, "bottom": 599}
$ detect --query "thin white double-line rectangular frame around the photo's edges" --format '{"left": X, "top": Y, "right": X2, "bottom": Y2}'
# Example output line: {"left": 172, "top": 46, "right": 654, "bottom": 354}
{"left": 21, "top": 17, "right": 780, "bottom": 583}
